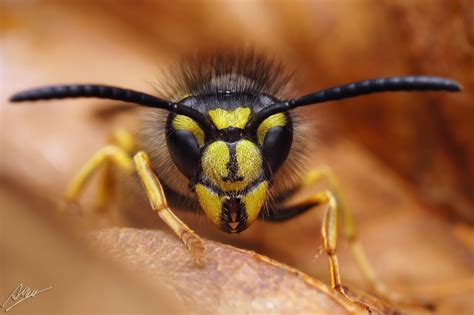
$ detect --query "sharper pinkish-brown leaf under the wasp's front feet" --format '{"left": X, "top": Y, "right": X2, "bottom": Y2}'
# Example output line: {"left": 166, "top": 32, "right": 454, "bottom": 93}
{"left": 90, "top": 229, "right": 389, "bottom": 314}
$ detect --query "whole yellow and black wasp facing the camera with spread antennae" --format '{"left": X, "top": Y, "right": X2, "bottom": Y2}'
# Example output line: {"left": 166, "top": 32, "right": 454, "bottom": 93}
{"left": 11, "top": 52, "right": 461, "bottom": 312}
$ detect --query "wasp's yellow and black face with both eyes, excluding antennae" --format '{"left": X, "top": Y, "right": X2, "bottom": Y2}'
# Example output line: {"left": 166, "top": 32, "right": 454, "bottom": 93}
{"left": 166, "top": 92, "right": 293, "bottom": 233}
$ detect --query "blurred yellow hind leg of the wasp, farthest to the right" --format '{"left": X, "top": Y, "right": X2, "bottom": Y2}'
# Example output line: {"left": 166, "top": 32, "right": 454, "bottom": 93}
{"left": 301, "top": 166, "right": 433, "bottom": 308}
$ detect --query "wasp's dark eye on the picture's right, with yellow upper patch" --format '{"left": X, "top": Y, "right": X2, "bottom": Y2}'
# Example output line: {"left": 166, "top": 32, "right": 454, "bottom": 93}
{"left": 257, "top": 113, "right": 293, "bottom": 173}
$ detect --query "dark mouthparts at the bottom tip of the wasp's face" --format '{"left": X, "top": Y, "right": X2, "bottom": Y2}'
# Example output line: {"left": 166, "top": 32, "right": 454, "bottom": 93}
{"left": 220, "top": 197, "right": 248, "bottom": 233}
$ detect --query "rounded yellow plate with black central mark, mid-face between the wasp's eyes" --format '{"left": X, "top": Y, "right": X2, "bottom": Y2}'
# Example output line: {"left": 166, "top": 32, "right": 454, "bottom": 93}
{"left": 201, "top": 140, "right": 262, "bottom": 191}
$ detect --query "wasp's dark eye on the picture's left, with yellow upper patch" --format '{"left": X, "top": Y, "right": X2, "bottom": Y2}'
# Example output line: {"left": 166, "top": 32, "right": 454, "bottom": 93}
{"left": 166, "top": 115, "right": 204, "bottom": 179}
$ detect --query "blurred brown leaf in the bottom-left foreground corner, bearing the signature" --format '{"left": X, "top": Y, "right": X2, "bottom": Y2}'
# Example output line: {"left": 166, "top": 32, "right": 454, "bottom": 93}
{"left": 0, "top": 187, "right": 184, "bottom": 314}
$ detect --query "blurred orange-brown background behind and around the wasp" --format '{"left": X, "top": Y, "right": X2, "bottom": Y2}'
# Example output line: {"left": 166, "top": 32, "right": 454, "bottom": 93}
{"left": 0, "top": 0, "right": 474, "bottom": 313}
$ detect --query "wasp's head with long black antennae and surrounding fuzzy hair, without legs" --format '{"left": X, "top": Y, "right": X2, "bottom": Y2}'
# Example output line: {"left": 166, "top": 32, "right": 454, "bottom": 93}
{"left": 11, "top": 53, "right": 461, "bottom": 237}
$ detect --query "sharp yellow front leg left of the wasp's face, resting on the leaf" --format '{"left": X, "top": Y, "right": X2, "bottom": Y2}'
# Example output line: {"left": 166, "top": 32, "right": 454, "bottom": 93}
{"left": 133, "top": 151, "right": 204, "bottom": 265}
